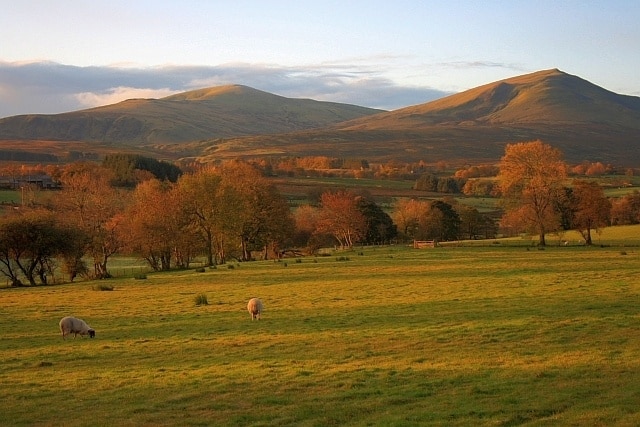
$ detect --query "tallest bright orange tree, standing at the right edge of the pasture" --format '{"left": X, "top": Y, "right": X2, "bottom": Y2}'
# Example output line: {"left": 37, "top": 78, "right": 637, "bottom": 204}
{"left": 498, "top": 141, "right": 566, "bottom": 246}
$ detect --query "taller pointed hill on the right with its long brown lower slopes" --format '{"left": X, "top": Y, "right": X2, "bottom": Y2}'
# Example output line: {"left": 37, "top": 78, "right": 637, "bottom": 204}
{"left": 196, "top": 69, "right": 640, "bottom": 166}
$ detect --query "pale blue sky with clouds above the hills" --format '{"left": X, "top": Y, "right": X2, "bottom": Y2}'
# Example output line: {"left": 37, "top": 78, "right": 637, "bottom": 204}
{"left": 0, "top": 0, "right": 640, "bottom": 117}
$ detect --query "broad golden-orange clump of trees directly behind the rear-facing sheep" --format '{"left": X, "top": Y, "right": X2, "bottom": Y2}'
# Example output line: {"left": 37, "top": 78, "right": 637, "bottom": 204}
{"left": 178, "top": 161, "right": 293, "bottom": 265}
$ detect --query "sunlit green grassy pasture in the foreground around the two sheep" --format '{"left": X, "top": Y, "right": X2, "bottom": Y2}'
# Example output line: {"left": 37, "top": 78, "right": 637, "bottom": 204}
{"left": 0, "top": 232, "right": 640, "bottom": 426}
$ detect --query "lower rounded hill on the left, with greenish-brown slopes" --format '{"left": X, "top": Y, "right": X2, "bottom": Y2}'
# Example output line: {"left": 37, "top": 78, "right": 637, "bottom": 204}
{"left": 0, "top": 85, "right": 381, "bottom": 145}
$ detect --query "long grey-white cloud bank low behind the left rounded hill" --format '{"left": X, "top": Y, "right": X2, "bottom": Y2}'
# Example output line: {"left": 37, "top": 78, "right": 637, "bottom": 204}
{"left": 0, "top": 61, "right": 448, "bottom": 117}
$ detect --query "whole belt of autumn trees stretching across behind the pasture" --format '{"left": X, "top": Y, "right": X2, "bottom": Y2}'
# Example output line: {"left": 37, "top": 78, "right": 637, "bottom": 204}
{"left": 0, "top": 141, "right": 640, "bottom": 286}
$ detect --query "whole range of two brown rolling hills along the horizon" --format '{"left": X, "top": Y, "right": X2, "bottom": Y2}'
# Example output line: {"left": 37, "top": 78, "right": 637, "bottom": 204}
{"left": 0, "top": 69, "right": 640, "bottom": 167}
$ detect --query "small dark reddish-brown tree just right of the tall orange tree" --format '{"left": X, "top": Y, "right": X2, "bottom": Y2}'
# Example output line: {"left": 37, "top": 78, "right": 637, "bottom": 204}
{"left": 570, "top": 181, "right": 611, "bottom": 245}
